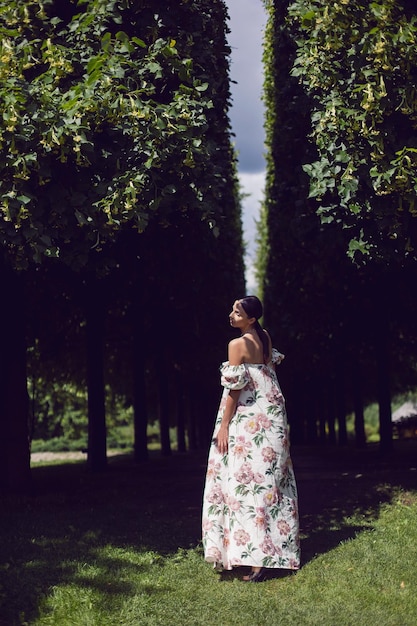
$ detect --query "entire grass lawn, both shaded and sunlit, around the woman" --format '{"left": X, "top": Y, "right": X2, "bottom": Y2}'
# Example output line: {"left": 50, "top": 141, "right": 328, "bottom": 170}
{"left": 0, "top": 441, "right": 417, "bottom": 626}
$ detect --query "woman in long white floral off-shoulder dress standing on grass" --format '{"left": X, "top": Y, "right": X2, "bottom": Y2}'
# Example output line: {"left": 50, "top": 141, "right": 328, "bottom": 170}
{"left": 203, "top": 296, "right": 300, "bottom": 582}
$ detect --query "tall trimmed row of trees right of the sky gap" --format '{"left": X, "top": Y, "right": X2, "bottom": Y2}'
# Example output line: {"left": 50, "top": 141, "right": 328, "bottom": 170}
{"left": 258, "top": 0, "right": 417, "bottom": 450}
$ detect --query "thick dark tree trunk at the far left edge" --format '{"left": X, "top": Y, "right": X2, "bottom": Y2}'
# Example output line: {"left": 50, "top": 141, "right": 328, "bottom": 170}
{"left": 0, "top": 266, "right": 31, "bottom": 492}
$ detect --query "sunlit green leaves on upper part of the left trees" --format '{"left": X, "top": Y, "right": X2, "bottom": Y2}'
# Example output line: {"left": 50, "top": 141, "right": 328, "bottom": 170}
{"left": 0, "top": 0, "right": 214, "bottom": 267}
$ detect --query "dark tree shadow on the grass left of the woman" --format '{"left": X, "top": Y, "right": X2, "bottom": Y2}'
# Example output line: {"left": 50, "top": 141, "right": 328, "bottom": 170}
{"left": 0, "top": 455, "right": 203, "bottom": 626}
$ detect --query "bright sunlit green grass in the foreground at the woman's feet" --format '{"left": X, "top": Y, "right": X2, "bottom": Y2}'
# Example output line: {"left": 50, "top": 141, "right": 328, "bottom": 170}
{"left": 34, "top": 500, "right": 417, "bottom": 626}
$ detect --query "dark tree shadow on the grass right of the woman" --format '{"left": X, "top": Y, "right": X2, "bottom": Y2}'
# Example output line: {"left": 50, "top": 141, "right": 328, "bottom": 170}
{"left": 293, "top": 441, "right": 417, "bottom": 565}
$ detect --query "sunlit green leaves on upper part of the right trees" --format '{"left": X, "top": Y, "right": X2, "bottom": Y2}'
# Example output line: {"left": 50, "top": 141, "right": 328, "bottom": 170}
{"left": 288, "top": 0, "right": 417, "bottom": 260}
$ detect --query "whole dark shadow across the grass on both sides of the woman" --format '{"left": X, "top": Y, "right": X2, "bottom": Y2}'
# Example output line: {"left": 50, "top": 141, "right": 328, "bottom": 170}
{"left": 0, "top": 442, "right": 417, "bottom": 626}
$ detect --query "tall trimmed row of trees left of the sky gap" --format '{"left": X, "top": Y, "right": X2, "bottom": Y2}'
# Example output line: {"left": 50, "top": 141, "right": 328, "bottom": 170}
{"left": 0, "top": 0, "right": 244, "bottom": 490}
